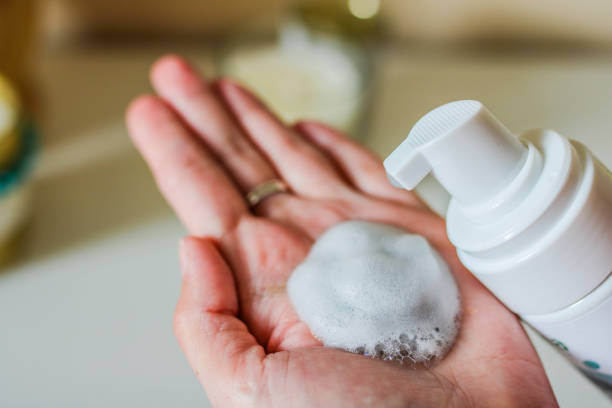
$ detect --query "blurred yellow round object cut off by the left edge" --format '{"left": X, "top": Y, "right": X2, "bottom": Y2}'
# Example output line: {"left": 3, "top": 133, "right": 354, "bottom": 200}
{"left": 0, "top": 75, "right": 21, "bottom": 169}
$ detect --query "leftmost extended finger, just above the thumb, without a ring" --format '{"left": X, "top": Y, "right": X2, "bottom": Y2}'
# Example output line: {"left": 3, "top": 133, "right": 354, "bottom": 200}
{"left": 127, "top": 96, "right": 246, "bottom": 237}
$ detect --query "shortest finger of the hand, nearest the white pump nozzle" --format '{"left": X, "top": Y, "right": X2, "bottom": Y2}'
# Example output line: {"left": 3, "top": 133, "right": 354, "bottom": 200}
{"left": 295, "top": 121, "right": 425, "bottom": 208}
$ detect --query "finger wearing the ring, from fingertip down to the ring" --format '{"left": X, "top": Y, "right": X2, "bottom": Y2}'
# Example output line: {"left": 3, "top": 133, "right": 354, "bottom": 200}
{"left": 151, "top": 56, "right": 276, "bottom": 192}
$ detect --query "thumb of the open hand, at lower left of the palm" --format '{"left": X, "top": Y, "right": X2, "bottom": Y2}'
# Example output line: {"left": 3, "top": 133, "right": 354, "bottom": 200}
{"left": 174, "top": 238, "right": 265, "bottom": 403}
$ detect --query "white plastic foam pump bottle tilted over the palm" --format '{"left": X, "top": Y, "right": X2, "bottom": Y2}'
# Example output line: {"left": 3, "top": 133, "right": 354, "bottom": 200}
{"left": 384, "top": 100, "right": 612, "bottom": 396}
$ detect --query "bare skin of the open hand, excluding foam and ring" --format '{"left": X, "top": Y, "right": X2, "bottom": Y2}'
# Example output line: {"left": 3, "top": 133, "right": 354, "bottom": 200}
{"left": 127, "top": 56, "right": 557, "bottom": 407}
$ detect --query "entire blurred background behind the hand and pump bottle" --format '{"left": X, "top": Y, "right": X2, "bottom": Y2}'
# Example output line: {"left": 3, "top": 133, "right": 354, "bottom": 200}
{"left": 0, "top": 0, "right": 612, "bottom": 407}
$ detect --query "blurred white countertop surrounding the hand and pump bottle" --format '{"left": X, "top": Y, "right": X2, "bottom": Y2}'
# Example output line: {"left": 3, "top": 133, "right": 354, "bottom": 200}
{"left": 0, "top": 46, "right": 612, "bottom": 407}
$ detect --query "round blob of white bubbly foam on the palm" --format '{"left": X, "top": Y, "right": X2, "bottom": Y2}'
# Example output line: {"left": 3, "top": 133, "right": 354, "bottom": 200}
{"left": 287, "top": 221, "right": 460, "bottom": 363}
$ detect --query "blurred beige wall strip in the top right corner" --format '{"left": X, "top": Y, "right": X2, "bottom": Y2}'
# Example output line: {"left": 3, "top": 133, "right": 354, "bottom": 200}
{"left": 382, "top": 0, "right": 612, "bottom": 42}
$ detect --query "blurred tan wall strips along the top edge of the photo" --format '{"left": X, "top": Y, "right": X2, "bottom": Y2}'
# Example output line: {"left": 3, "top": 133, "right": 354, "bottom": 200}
{"left": 41, "top": 0, "right": 612, "bottom": 42}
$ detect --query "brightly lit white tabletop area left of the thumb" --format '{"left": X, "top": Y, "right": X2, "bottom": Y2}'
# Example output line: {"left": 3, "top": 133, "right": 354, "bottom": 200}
{"left": 0, "top": 220, "right": 206, "bottom": 408}
